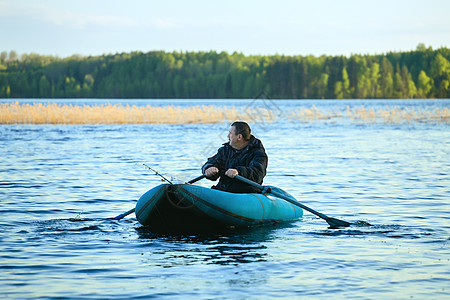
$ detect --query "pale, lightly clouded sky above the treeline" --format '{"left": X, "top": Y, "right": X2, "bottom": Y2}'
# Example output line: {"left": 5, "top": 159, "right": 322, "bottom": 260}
{"left": 0, "top": 0, "right": 450, "bottom": 57}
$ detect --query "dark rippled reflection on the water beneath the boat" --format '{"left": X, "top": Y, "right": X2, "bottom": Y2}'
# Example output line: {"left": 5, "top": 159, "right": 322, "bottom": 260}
{"left": 136, "top": 224, "right": 291, "bottom": 268}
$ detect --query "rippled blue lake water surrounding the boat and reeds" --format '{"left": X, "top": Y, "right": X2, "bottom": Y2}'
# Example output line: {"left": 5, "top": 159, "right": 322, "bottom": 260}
{"left": 0, "top": 100, "right": 450, "bottom": 299}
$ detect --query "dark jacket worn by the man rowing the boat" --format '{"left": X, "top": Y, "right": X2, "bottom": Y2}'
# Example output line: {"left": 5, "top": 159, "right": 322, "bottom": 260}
{"left": 202, "top": 135, "right": 268, "bottom": 193}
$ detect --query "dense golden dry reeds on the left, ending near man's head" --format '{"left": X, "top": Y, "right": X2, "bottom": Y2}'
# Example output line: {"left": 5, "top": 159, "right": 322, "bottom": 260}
{"left": 0, "top": 102, "right": 274, "bottom": 124}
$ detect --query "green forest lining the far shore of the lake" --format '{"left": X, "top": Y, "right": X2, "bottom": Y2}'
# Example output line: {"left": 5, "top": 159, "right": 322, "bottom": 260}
{"left": 0, "top": 44, "right": 450, "bottom": 99}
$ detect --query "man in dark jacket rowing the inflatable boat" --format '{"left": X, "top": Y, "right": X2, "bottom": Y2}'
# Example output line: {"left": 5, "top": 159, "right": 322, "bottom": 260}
{"left": 202, "top": 122, "right": 268, "bottom": 193}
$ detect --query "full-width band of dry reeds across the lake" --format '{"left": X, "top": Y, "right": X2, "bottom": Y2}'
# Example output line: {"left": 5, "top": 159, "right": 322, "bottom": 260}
{"left": 0, "top": 102, "right": 450, "bottom": 124}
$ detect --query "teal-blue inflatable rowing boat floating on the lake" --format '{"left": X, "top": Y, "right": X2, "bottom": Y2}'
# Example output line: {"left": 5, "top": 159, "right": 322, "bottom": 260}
{"left": 135, "top": 184, "right": 303, "bottom": 230}
